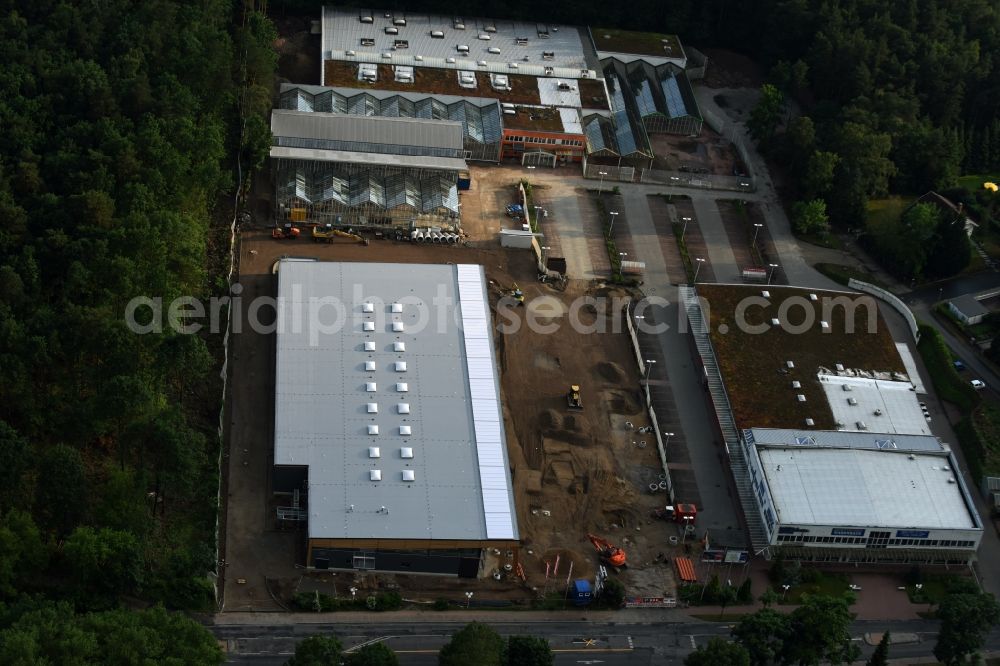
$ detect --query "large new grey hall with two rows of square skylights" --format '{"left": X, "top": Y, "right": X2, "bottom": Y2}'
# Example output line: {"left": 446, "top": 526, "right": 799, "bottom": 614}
{"left": 273, "top": 259, "right": 518, "bottom": 577}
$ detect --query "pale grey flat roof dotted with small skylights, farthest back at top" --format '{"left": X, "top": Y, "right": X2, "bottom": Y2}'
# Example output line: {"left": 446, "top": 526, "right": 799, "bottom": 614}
{"left": 321, "top": 6, "right": 593, "bottom": 78}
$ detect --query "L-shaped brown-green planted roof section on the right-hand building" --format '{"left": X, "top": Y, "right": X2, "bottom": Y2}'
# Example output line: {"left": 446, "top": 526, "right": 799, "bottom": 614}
{"left": 698, "top": 284, "right": 905, "bottom": 430}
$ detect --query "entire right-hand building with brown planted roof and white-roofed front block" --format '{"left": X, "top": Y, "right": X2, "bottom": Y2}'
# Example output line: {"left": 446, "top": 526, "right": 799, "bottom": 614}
{"left": 682, "top": 285, "right": 983, "bottom": 565}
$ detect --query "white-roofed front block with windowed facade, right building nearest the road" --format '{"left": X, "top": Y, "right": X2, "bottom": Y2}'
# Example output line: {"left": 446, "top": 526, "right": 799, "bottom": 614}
{"left": 740, "top": 428, "right": 983, "bottom": 564}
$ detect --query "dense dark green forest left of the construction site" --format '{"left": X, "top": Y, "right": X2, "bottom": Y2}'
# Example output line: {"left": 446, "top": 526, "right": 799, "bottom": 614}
{"left": 0, "top": 0, "right": 275, "bottom": 652}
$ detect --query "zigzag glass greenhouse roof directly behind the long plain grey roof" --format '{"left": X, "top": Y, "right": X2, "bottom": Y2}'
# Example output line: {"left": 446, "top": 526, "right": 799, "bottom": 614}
{"left": 279, "top": 83, "right": 503, "bottom": 162}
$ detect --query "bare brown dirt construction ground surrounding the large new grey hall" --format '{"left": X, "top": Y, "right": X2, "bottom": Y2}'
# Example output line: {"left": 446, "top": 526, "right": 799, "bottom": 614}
{"left": 224, "top": 229, "right": 676, "bottom": 610}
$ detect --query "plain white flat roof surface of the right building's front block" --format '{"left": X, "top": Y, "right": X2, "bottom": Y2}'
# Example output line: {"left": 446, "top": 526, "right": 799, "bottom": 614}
{"left": 757, "top": 447, "right": 981, "bottom": 530}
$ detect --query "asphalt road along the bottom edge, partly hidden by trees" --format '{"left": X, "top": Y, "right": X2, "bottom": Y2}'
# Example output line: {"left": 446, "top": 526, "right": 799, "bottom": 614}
{"left": 211, "top": 615, "right": 1000, "bottom": 666}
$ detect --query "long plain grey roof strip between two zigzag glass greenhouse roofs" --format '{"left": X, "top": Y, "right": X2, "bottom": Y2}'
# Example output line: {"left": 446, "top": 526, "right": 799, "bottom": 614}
{"left": 271, "top": 109, "right": 462, "bottom": 152}
